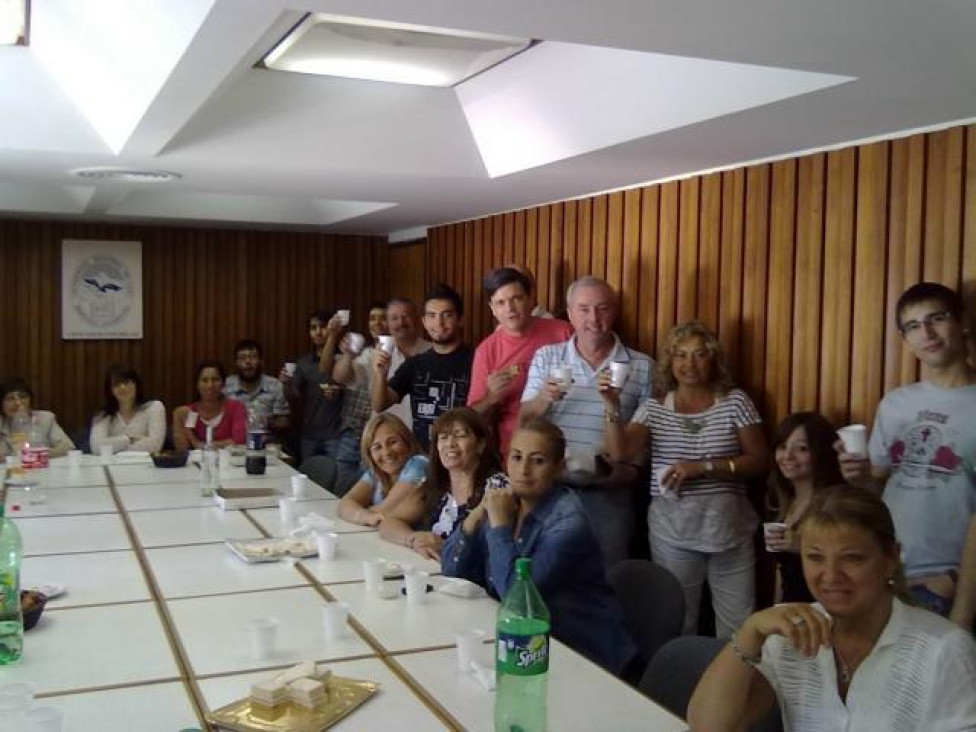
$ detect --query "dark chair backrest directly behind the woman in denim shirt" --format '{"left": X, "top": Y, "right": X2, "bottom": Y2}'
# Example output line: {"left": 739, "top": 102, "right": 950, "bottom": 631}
{"left": 607, "top": 559, "right": 685, "bottom": 663}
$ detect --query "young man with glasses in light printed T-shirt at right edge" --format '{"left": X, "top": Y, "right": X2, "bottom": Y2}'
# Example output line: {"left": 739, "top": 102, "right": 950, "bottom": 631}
{"left": 840, "top": 282, "right": 976, "bottom": 629}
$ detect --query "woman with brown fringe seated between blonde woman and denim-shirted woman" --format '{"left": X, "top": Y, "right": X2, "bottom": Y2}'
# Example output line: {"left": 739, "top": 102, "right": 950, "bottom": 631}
{"left": 380, "top": 407, "right": 504, "bottom": 560}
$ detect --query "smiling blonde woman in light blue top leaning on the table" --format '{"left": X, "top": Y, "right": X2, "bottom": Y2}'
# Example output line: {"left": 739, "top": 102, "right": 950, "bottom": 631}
{"left": 339, "top": 413, "right": 427, "bottom": 526}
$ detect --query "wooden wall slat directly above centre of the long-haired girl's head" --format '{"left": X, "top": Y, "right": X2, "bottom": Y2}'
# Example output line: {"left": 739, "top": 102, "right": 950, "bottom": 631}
{"left": 790, "top": 153, "right": 826, "bottom": 412}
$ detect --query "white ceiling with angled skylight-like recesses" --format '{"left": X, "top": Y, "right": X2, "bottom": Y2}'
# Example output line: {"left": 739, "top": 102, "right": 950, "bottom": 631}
{"left": 0, "top": 0, "right": 976, "bottom": 237}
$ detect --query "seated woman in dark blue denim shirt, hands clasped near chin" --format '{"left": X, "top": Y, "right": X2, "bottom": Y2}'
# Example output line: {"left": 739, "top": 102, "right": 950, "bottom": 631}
{"left": 441, "top": 419, "right": 636, "bottom": 674}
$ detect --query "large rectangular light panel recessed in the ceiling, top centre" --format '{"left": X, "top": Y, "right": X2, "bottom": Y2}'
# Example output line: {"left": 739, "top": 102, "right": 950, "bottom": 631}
{"left": 262, "top": 13, "right": 532, "bottom": 86}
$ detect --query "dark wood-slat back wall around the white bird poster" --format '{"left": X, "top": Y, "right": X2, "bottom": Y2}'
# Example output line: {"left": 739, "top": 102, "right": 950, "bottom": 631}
{"left": 0, "top": 220, "right": 389, "bottom": 430}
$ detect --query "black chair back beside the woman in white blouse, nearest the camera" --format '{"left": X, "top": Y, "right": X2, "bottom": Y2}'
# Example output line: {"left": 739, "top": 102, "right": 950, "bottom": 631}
{"left": 638, "top": 635, "right": 783, "bottom": 732}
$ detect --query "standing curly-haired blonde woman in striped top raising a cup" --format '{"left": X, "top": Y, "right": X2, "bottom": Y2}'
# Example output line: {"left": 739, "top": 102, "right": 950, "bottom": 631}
{"left": 601, "top": 321, "right": 769, "bottom": 638}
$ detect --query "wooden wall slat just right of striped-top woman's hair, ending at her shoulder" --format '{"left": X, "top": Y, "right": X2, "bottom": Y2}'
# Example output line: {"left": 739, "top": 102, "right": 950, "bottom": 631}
{"left": 733, "top": 165, "right": 770, "bottom": 409}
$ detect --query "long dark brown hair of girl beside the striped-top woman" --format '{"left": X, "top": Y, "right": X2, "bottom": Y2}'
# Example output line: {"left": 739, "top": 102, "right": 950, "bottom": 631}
{"left": 766, "top": 412, "right": 844, "bottom": 521}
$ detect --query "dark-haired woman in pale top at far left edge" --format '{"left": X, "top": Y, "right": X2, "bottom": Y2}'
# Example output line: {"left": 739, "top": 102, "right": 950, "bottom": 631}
{"left": 0, "top": 378, "right": 75, "bottom": 458}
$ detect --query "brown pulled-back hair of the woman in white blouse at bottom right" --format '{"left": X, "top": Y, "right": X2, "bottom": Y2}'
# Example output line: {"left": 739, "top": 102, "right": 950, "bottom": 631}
{"left": 799, "top": 483, "right": 910, "bottom": 602}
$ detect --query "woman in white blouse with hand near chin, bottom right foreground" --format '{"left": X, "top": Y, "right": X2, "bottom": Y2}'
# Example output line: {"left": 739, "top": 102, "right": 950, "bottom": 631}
{"left": 688, "top": 485, "right": 976, "bottom": 732}
